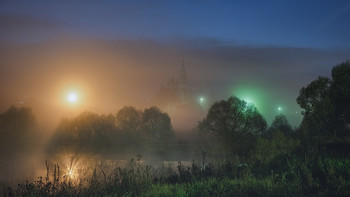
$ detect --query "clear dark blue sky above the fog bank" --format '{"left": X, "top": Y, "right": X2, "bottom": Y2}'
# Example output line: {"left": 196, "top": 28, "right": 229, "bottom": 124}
{"left": 0, "top": 0, "right": 350, "bottom": 48}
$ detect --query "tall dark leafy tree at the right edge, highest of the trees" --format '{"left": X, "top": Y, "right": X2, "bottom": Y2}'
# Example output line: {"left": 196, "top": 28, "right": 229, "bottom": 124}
{"left": 297, "top": 62, "right": 350, "bottom": 137}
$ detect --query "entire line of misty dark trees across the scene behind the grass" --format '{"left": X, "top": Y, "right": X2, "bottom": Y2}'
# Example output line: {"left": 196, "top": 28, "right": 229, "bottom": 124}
{"left": 0, "top": 62, "right": 350, "bottom": 159}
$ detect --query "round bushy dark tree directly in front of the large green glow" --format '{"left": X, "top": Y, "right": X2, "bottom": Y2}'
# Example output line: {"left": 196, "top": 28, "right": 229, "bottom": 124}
{"left": 197, "top": 97, "right": 267, "bottom": 153}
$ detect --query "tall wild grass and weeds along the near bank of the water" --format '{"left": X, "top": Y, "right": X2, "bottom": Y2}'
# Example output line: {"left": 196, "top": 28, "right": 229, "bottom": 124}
{"left": 3, "top": 155, "right": 350, "bottom": 197}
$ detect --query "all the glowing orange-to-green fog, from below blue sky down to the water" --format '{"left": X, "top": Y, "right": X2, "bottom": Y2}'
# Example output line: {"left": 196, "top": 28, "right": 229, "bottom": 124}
{"left": 0, "top": 37, "right": 349, "bottom": 185}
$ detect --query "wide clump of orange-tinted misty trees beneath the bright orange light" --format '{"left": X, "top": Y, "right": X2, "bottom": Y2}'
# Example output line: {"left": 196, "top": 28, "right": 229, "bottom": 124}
{"left": 48, "top": 106, "right": 174, "bottom": 152}
